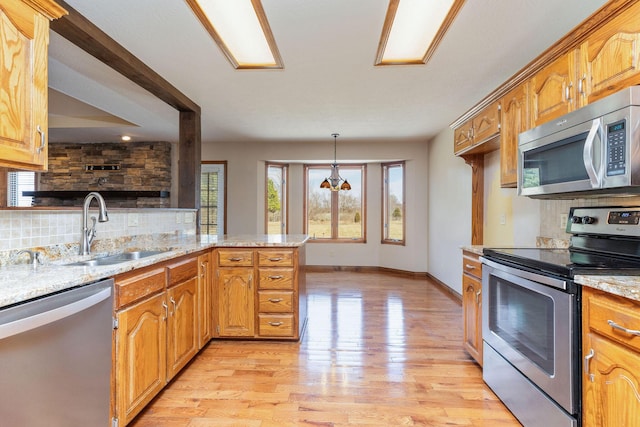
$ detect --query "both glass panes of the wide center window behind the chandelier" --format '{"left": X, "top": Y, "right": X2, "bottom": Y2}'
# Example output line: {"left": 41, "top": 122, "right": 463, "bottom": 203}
{"left": 305, "top": 165, "right": 366, "bottom": 242}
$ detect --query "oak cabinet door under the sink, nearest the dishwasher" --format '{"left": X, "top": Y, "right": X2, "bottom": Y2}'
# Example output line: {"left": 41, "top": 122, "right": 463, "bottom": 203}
{"left": 115, "top": 292, "right": 167, "bottom": 425}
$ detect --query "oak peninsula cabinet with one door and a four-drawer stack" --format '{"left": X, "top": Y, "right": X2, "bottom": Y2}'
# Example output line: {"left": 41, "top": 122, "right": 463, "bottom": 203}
{"left": 214, "top": 246, "right": 307, "bottom": 340}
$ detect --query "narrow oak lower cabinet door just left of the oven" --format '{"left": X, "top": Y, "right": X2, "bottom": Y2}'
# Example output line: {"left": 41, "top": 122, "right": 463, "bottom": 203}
{"left": 462, "top": 275, "right": 482, "bottom": 366}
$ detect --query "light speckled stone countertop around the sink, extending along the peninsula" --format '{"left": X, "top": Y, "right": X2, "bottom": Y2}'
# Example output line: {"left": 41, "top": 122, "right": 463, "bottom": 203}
{"left": 0, "top": 234, "right": 308, "bottom": 307}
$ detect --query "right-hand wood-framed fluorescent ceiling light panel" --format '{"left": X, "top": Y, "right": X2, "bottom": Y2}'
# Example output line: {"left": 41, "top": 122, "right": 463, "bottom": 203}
{"left": 376, "top": 0, "right": 464, "bottom": 65}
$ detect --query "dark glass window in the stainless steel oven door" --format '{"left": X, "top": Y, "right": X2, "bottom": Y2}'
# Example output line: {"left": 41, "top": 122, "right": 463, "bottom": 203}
{"left": 489, "top": 276, "right": 554, "bottom": 375}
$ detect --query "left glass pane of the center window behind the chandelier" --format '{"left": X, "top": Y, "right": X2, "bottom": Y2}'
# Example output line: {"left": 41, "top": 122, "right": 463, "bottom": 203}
{"left": 307, "top": 168, "right": 331, "bottom": 239}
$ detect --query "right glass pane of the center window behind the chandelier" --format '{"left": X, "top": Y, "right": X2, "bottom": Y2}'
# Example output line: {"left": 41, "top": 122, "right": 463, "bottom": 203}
{"left": 338, "top": 168, "right": 363, "bottom": 239}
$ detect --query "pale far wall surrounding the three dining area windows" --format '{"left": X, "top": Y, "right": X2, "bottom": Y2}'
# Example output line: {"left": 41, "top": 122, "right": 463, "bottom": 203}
{"left": 202, "top": 137, "right": 430, "bottom": 272}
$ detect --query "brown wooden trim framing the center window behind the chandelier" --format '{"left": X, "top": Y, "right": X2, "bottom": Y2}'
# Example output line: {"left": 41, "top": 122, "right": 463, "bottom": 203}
{"left": 302, "top": 163, "right": 367, "bottom": 243}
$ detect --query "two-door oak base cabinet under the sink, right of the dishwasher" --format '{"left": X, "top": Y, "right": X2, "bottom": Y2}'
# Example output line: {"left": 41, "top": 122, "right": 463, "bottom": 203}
{"left": 111, "top": 255, "right": 205, "bottom": 426}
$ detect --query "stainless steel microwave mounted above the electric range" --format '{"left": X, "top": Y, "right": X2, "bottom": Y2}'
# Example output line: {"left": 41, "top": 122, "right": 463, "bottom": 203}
{"left": 518, "top": 86, "right": 640, "bottom": 198}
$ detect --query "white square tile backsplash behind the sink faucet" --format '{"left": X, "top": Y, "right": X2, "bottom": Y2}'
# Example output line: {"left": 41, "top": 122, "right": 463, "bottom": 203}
{"left": 0, "top": 209, "right": 197, "bottom": 251}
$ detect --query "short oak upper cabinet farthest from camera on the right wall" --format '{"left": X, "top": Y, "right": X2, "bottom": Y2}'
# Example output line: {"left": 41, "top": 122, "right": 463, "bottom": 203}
{"left": 453, "top": 101, "right": 501, "bottom": 155}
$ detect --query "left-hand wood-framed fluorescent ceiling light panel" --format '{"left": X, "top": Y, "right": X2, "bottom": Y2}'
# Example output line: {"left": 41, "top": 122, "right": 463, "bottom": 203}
{"left": 186, "top": 0, "right": 283, "bottom": 68}
